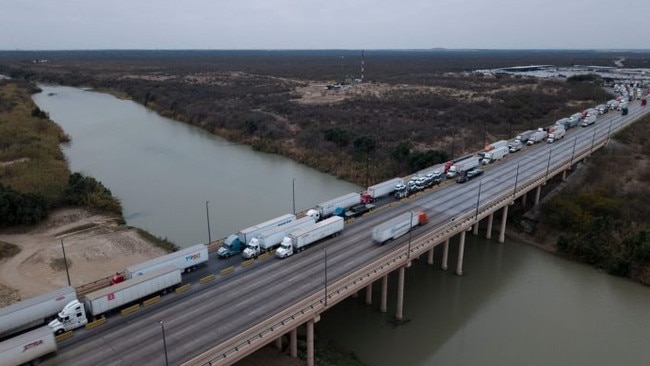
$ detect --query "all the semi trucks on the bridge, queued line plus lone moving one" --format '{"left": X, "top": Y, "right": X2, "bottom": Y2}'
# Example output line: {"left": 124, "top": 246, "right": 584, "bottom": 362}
{"left": 0, "top": 86, "right": 645, "bottom": 366}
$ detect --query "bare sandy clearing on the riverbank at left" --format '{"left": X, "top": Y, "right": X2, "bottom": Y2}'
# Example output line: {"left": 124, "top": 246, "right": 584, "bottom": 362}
{"left": 0, "top": 209, "right": 165, "bottom": 306}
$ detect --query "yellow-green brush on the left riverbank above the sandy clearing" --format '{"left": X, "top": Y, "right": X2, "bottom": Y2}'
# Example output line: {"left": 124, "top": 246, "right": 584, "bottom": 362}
{"left": 0, "top": 80, "right": 122, "bottom": 227}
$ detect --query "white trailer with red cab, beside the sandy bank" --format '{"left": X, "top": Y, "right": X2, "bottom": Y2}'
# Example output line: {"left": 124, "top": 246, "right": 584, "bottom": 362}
{"left": 125, "top": 244, "right": 208, "bottom": 283}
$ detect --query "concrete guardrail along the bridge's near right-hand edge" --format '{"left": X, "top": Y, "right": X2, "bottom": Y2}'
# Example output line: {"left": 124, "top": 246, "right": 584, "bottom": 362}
{"left": 182, "top": 104, "right": 641, "bottom": 366}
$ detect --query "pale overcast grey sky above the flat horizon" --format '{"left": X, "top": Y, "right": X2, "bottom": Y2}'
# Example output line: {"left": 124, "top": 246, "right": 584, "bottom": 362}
{"left": 0, "top": 0, "right": 650, "bottom": 50}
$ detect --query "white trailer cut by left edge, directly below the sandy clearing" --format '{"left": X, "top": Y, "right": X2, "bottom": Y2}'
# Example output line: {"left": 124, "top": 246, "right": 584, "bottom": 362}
{"left": 0, "top": 286, "right": 77, "bottom": 337}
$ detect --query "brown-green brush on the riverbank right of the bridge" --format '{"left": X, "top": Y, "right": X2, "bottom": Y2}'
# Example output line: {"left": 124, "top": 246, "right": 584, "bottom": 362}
{"left": 542, "top": 116, "right": 650, "bottom": 285}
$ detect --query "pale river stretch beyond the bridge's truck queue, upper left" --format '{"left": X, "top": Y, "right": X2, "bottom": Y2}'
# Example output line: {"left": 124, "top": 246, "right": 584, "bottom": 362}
{"left": 33, "top": 85, "right": 361, "bottom": 247}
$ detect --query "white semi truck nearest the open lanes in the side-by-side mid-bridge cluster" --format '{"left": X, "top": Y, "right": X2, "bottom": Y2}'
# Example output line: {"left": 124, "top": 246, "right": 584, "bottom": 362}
{"left": 275, "top": 216, "right": 344, "bottom": 258}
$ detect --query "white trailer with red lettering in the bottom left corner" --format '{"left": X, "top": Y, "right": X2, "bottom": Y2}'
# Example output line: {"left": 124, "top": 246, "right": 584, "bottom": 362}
{"left": 0, "top": 326, "right": 57, "bottom": 366}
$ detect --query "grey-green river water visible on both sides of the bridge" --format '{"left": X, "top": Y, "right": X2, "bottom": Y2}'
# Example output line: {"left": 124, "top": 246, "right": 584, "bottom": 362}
{"left": 34, "top": 86, "right": 650, "bottom": 366}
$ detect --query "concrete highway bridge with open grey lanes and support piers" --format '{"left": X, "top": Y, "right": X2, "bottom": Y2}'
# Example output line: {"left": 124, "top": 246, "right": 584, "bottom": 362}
{"left": 43, "top": 102, "right": 647, "bottom": 366}
